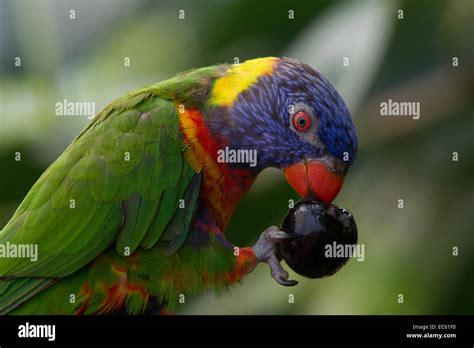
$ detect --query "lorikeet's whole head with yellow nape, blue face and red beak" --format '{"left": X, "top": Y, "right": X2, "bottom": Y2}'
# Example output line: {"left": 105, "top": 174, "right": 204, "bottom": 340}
{"left": 208, "top": 58, "right": 357, "bottom": 203}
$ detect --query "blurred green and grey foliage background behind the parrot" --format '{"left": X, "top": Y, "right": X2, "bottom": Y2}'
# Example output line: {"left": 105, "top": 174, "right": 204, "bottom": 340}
{"left": 0, "top": 0, "right": 474, "bottom": 314}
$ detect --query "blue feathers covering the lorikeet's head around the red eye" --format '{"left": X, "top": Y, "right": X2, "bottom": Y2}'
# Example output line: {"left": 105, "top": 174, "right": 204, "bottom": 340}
{"left": 206, "top": 58, "right": 357, "bottom": 169}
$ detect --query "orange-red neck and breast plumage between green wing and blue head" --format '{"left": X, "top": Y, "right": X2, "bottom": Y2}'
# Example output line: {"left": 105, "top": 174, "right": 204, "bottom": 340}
{"left": 178, "top": 109, "right": 259, "bottom": 233}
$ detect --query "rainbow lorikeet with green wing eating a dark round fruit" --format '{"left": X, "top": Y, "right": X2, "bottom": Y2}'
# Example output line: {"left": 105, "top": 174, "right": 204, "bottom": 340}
{"left": 0, "top": 57, "right": 357, "bottom": 314}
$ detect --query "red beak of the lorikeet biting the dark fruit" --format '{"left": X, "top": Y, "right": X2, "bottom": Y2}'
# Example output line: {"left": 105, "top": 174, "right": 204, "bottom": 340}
{"left": 283, "top": 160, "right": 344, "bottom": 204}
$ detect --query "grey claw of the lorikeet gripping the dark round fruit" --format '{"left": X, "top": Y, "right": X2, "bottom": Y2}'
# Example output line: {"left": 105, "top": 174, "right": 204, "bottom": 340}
{"left": 253, "top": 226, "right": 298, "bottom": 286}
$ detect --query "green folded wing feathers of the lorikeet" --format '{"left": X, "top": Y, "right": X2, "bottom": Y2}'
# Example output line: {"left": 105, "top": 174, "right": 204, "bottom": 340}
{"left": 0, "top": 87, "right": 201, "bottom": 312}
